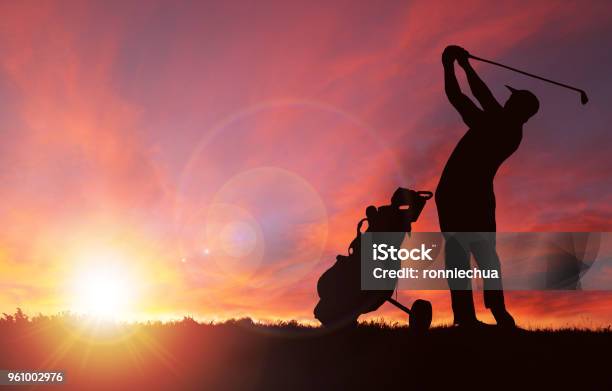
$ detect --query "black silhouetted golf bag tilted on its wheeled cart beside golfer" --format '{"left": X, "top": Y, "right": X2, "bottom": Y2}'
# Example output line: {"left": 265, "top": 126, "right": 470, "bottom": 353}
{"left": 314, "top": 187, "right": 433, "bottom": 326}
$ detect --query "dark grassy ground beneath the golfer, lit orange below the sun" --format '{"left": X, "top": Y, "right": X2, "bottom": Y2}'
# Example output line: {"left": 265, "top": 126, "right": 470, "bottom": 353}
{"left": 0, "top": 317, "right": 612, "bottom": 390}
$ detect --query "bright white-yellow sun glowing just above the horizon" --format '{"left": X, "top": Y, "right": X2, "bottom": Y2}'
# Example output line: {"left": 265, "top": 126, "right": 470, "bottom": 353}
{"left": 72, "top": 253, "right": 136, "bottom": 319}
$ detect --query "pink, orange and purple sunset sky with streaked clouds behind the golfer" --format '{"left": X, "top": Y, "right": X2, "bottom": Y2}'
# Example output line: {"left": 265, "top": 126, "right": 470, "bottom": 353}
{"left": 0, "top": 1, "right": 612, "bottom": 327}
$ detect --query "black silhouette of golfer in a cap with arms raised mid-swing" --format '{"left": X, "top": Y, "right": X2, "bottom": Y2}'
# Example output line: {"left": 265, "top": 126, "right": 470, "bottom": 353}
{"left": 435, "top": 46, "right": 539, "bottom": 327}
